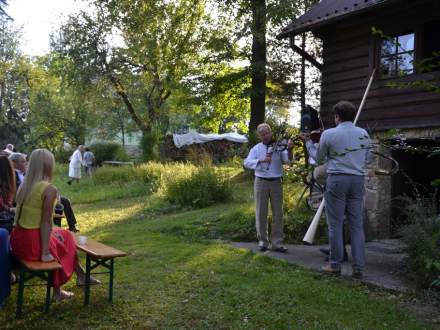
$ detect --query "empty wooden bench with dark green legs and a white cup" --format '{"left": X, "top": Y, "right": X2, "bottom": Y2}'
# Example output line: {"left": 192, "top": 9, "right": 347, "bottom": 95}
{"left": 75, "top": 235, "right": 127, "bottom": 305}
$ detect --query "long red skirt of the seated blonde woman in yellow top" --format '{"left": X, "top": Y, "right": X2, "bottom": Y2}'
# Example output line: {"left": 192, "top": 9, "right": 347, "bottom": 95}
{"left": 11, "top": 227, "right": 78, "bottom": 288}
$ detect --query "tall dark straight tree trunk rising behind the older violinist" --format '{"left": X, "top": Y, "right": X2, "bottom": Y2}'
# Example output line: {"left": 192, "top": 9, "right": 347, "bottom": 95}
{"left": 249, "top": 0, "right": 267, "bottom": 134}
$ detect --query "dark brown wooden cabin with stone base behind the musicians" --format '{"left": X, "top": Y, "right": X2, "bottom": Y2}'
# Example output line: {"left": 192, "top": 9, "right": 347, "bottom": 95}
{"left": 279, "top": 0, "right": 440, "bottom": 238}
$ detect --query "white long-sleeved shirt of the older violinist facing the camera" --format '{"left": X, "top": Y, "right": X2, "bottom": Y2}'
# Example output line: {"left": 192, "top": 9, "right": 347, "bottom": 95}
{"left": 244, "top": 142, "right": 290, "bottom": 178}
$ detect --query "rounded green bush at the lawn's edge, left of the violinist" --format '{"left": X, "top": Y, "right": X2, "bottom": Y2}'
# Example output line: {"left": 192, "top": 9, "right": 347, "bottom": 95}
{"left": 165, "top": 167, "right": 232, "bottom": 208}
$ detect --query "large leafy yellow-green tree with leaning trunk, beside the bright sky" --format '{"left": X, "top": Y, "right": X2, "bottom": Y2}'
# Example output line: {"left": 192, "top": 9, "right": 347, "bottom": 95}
{"left": 53, "top": 0, "right": 211, "bottom": 157}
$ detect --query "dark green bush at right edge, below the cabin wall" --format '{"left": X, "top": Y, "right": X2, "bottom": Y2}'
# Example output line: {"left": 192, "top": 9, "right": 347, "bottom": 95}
{"left": 401, "top": 198, "right": 440, "bottom": 290}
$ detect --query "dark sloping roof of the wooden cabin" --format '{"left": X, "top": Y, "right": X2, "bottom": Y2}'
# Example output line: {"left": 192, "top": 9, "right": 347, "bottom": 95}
{"left": 278, "top": 0, "right": 392, "bottom": 38}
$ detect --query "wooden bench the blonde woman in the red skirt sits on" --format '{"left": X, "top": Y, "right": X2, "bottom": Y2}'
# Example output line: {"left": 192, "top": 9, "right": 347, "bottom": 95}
{"left": 15, "top": 258, "right": 62, "bottom": 319}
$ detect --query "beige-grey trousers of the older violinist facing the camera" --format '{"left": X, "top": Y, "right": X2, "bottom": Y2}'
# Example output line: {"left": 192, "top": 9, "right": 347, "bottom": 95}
{"left": 254, "top": 177, "right": 283, "bottom": 249}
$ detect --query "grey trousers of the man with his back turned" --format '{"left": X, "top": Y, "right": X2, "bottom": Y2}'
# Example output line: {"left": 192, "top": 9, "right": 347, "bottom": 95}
{"left": 324, "top": 174, "right": 365, "bottom": 271}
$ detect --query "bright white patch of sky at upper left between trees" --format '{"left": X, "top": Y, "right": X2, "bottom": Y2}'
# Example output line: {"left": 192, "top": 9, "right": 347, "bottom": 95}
{"left": 6, "top": 0, "right": 86, "bottom": 56}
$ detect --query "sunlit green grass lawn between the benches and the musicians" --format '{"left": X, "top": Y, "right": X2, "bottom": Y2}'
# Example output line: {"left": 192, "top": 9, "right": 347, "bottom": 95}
{"left": 0, "top": 166, "right": 432, "bottom": 329}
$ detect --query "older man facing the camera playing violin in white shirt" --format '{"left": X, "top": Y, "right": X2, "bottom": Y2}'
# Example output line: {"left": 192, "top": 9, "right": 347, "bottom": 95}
{"left": 244, "top": 123, "right": 293, "bottom": 253}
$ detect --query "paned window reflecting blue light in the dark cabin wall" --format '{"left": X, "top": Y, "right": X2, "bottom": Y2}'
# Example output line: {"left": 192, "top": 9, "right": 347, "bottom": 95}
{"left": 380, "top": 33, "right": 414, "bottom": 78}
